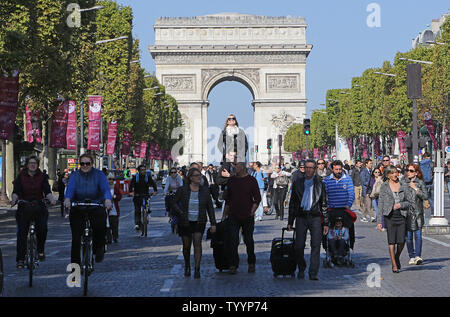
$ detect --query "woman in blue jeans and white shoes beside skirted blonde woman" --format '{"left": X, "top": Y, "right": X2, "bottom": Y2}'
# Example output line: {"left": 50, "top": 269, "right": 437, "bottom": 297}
{"left": 405, "top": 164, "right": 428, "bottom": 265}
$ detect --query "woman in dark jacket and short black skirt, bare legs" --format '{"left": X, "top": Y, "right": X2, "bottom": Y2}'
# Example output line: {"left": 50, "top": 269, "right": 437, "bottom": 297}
{"left": 171, "top": 168, "right": 216, "bottom": 278}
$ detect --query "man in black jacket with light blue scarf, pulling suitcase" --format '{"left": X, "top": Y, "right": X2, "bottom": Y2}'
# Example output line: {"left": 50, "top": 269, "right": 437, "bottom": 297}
{"left": 288, "top": 160, "right": 328, "bottom": 280}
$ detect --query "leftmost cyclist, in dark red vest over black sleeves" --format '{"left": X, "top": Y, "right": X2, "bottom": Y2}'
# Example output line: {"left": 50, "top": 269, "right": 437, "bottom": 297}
{"left": 11, "top": 156, "right": 56, "bottom": 269}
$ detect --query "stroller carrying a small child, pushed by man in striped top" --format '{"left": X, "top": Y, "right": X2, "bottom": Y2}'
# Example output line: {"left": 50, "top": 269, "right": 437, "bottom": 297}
{"left": 322, "top": 209, "right": 355, "bottom": 268}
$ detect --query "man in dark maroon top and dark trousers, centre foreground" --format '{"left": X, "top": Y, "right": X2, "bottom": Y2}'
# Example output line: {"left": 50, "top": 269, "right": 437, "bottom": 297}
{"left": 222, "top": 162, "right": 261, "bottom": 274}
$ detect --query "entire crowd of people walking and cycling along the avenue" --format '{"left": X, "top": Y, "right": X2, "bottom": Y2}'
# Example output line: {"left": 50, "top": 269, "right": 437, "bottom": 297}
{"left": 12, "top": 115, "right": 450, "bottom": 280}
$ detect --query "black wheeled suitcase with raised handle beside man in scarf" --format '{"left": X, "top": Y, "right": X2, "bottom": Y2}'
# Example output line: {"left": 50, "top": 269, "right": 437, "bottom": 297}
{"left": 270, "top": 228, "right": 297, "bottom": 277}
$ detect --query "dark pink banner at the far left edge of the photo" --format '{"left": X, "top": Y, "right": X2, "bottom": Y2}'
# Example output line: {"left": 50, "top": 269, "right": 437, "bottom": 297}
{"left": 0, "top": 72, "right": 19, "bottom": 140}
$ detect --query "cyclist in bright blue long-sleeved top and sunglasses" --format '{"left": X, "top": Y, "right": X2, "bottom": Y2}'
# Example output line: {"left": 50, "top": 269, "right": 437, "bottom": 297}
{"left": 64, "top": 154, "right": 112, "bottom": 265}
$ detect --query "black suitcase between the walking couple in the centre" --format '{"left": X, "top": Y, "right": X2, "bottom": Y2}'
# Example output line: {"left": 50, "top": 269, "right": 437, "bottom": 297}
{"left": 207, "top": 220, "right": 231, "bottom": 272}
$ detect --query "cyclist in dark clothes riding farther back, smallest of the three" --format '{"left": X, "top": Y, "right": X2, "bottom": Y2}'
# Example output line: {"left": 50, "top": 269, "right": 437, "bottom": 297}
{"left": 130, "top": 165, "right": 158, "bottom": 231}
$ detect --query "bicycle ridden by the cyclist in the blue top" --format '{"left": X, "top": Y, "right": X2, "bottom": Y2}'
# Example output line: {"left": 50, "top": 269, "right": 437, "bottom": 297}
{"left": 71, "top": 200, "right": 104, "bottom": 296}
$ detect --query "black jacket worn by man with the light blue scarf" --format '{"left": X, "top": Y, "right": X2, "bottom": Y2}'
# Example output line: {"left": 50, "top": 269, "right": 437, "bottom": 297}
{"left": 288, "top": 175, "right": 329, "bottom": 226}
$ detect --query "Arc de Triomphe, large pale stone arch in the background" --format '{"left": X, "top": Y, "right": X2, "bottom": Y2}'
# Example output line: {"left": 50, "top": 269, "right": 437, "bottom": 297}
{"left": 149, "top": 13, "right": 312, "bottom": 165}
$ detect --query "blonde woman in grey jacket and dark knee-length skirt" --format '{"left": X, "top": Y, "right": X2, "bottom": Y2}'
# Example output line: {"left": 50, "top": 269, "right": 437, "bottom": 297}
{"left": 377, "top": 166, "right": 414, "bottom": 273}
